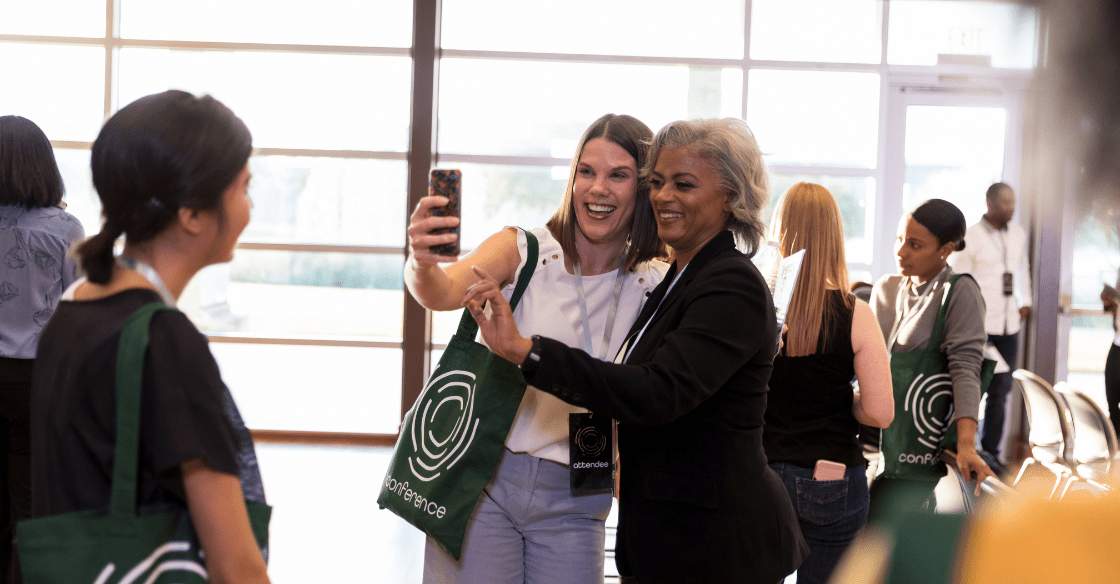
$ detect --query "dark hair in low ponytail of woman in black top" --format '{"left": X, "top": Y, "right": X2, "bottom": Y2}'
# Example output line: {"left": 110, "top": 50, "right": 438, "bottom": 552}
{"left": 77, "top": 90, "right": 253, "bottom": 284}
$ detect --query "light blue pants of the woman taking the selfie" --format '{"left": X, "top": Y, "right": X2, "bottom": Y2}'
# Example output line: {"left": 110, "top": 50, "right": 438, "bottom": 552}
{"left": 423, "top": 451, "right": 612, "bottom": 584}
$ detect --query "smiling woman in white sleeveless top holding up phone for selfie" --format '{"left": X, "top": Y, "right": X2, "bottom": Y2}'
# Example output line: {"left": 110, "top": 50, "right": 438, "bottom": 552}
{"left": 404, "top": 114, "right": 664, "bottom": 584}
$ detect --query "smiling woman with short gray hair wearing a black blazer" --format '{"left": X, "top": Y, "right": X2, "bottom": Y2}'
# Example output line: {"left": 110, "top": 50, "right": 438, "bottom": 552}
{"left": 466, "top": 119, "right": 808, "bottom": 584}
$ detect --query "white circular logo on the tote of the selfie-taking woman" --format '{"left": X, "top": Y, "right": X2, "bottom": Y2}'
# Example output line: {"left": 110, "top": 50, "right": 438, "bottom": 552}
{"left": 409, "top": 370, "right": 478, "bottom": 481}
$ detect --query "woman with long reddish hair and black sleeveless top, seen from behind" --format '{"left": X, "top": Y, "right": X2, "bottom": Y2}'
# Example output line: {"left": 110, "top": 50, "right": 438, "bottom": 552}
{"left": 763, "top": 183, "right": 895, "bottom": 584}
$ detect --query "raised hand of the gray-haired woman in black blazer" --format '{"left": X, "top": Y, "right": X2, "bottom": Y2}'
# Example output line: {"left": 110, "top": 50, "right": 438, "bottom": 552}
{"left": 463, "top": 266, "right": 533, "bottom": 365}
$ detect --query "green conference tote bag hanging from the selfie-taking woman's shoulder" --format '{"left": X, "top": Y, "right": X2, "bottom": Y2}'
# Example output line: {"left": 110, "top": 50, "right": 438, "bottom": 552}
{"left": 377, "top": 231, "right": 538, "bottom": 559}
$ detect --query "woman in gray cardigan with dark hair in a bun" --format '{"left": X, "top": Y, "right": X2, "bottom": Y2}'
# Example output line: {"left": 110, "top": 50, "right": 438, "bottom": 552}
{"left": 871, "top": 198, "right": 995, "bottom": 517}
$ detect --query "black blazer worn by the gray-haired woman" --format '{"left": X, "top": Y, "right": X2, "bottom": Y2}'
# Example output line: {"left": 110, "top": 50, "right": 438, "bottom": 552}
{"left": 526, "top": 231, "right": 809, "bottom": 584}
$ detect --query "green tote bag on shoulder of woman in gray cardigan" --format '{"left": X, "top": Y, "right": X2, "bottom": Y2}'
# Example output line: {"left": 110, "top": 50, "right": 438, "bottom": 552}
{"left": 879, "top": 274, "right": 996, "bottom": 482}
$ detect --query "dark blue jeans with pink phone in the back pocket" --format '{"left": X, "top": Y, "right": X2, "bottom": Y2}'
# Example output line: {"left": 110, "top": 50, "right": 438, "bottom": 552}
{"left": 771, "top": 463, "right": 868, "bottom": 584}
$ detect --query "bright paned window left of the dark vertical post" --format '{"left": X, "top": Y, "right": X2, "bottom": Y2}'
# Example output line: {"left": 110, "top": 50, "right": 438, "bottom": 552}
{"left": 0, "top": 0, "right": 412, "bottom": 435}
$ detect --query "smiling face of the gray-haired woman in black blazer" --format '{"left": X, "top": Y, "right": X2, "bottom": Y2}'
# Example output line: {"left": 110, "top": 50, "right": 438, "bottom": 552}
{"left": 650, "top": 148, "right": 731, "bottom": 266}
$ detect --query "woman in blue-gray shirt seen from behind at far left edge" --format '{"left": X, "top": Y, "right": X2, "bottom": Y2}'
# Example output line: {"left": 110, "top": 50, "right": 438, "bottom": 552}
{"left": 0, "top": 115, "right": 85, "bottom": 583}
